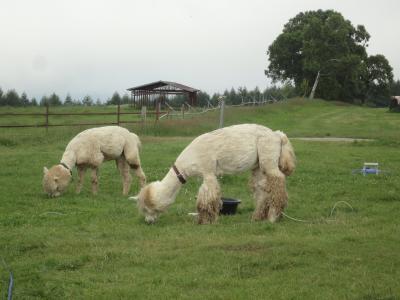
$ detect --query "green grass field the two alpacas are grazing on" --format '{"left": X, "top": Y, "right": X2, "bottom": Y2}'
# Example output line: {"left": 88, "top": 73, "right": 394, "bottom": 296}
{"left": 0, "top": 99, "right": 400, "bottom": 299}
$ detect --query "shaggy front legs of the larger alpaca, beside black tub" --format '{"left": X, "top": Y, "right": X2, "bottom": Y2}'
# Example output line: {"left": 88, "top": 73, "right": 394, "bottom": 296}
{"left": 197, "top": 176, "right": 222, "bottom": 224}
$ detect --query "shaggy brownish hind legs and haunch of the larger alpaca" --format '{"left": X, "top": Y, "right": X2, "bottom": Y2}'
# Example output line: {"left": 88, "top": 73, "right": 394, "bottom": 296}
{"left": 253, "top": 136, "right": 288, "bottom": 222}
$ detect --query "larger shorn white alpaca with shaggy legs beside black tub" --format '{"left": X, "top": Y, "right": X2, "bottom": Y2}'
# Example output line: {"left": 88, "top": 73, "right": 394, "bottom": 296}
{"left": 131, "top": 124, "right": 295, "bottom": 224}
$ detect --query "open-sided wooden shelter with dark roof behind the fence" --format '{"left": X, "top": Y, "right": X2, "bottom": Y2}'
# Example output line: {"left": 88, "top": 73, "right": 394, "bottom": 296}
{"left": 127, "top": 80, "right": 199, "bottom": 107}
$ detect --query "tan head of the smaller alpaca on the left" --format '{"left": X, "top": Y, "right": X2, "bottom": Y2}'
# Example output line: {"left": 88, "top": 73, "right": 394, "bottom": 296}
{"left": 42, "top": 165, "right": 72, "bottom": 197}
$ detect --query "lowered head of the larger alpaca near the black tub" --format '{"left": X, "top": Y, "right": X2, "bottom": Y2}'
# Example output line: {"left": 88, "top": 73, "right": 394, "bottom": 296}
{"left": 132, "top": 181, "right": 167, "bottom": 224}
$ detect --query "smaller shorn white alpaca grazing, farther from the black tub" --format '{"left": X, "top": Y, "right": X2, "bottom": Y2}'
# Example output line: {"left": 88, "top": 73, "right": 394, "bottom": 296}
{"left": 43, "top": 126, "right": 146, "bottom": 197}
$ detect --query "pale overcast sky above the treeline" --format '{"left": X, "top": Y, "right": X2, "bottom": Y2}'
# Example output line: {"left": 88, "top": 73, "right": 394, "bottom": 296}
{"left": 0, "top": 0, "right": 400, "bottom": 100}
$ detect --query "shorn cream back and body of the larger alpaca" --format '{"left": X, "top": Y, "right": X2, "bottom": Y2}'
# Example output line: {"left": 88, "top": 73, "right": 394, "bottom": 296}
{"left": 176, "top": 124, "right": 295, "bottom": 176}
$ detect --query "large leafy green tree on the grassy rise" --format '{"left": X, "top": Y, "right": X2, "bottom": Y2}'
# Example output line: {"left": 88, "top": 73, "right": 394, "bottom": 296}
{"left": 265, "top": 10, "right": 393, "bottom": 101}
